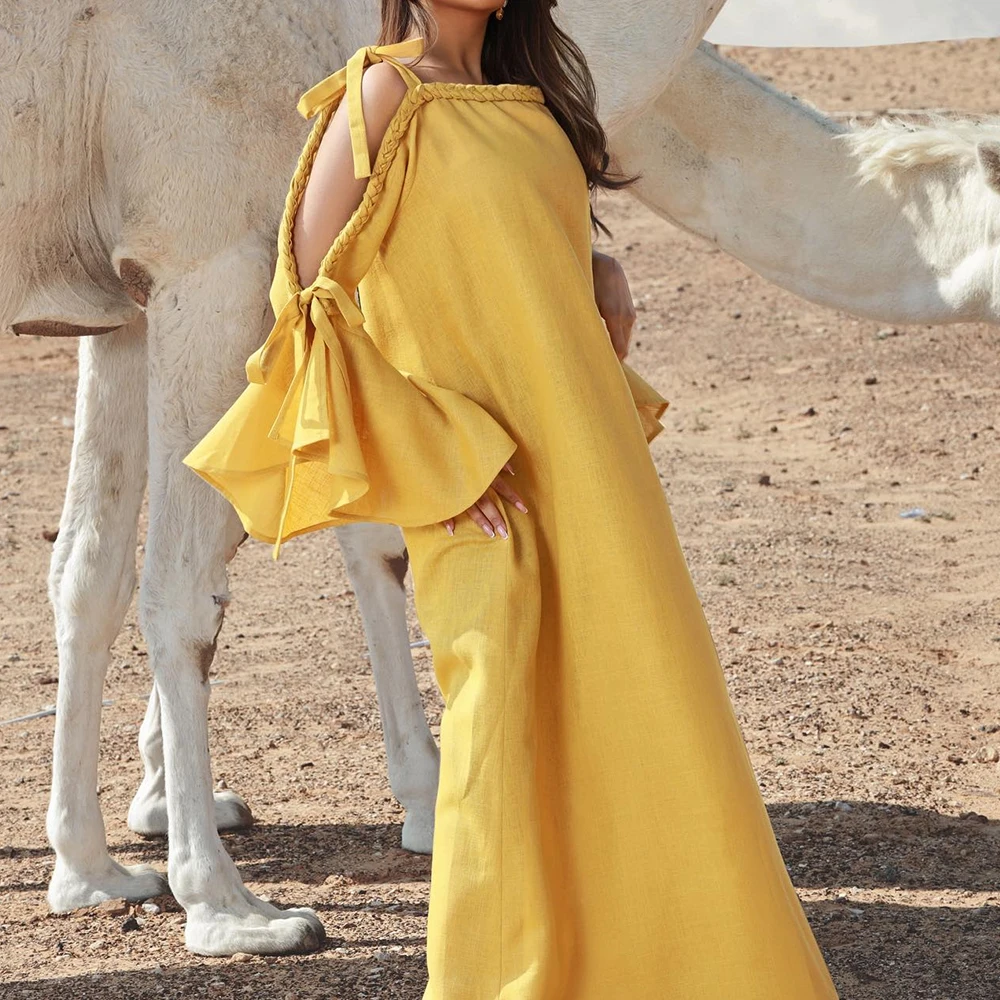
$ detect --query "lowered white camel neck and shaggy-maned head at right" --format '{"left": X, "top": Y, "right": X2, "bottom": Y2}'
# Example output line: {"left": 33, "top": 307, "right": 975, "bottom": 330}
{"left": 613, "top": 42, "right": 1000, "bottom": 324}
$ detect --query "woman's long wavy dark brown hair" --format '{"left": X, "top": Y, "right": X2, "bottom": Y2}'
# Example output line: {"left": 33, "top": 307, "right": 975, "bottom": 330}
{"left": 379, "top": 0, "right": 636, "bottom": 233}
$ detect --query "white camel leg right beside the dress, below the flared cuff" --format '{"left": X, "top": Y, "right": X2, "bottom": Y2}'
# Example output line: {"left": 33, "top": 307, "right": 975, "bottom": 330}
{"left": 336, "top": 524, "right": 443, "bottom": 854}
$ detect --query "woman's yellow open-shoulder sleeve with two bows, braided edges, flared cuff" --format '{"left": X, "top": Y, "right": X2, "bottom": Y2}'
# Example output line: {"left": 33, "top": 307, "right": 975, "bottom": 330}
{"left": 184, "top": 39, "right": 516, "bottom": 558}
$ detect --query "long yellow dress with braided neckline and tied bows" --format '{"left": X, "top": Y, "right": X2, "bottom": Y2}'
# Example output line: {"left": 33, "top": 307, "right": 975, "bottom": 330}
{"left": 185, "top": 39, "right": 836, "bottom": 1000}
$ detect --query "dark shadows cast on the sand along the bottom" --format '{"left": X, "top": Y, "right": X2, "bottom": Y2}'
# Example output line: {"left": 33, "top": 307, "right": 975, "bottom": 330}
{"left": 0, "top": 802, "right": 1000, "bottom": 1000}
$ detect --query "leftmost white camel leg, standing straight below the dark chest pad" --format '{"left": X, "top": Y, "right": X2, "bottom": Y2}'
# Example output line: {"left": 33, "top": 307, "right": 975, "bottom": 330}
{"left": 46, "top": 322, "right": 166, "bottom": 913}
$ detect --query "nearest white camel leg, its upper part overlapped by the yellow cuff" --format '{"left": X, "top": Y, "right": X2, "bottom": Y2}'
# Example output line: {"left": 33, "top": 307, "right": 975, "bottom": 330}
{"left": 139, "top": 243, "right": 323, "bottom": 955}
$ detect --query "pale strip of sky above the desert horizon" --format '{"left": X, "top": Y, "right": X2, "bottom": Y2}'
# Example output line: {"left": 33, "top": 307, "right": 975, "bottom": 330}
{"left": 707, "top": 0, "right": 1000, "bottom": 46}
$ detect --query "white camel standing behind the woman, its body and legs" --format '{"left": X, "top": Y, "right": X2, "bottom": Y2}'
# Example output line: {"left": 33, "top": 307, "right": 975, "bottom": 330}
{"left": 0, "top": 0, "right": 722, "bottom": 954}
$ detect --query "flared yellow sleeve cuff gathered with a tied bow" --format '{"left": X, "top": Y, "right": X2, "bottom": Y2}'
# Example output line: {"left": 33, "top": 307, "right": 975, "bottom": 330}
{"left": 184, "top": 276, "right": 516, "bottom": 556}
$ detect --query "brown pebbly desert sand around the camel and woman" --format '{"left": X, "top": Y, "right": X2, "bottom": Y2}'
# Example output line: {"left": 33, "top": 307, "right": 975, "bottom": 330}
{"left": 0, "top": 35, "right": 1000, "bottom": 1000}
